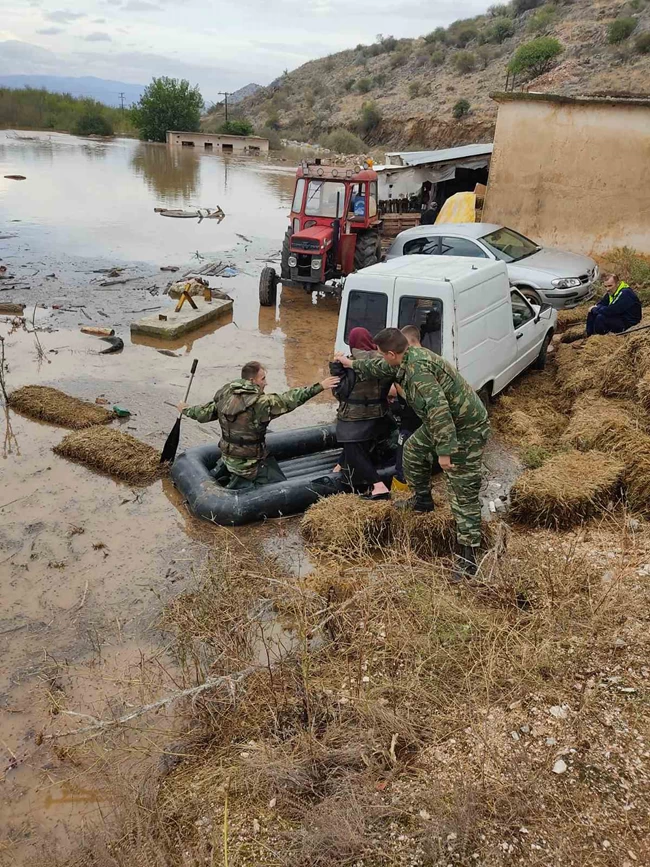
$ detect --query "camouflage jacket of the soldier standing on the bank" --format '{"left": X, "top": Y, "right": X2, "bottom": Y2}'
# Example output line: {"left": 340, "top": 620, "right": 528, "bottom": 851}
{"left": 352, "top": 346, "right": 488, "bottom": 455}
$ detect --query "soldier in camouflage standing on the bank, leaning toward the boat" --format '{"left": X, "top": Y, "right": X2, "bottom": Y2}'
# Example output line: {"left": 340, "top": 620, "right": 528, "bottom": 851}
{"left": 337, "top": 328, "right": 490, "bottom": 577}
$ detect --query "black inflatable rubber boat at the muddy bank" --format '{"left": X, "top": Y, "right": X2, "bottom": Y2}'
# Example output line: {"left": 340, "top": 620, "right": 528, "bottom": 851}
{"left": 171, "top": 425, "right": 395, "bottom": 525}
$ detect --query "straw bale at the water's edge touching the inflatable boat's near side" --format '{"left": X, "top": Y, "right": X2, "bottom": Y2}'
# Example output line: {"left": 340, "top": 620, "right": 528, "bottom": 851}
{"left": 300, "top": 494, "right": 392, "bottom": 558}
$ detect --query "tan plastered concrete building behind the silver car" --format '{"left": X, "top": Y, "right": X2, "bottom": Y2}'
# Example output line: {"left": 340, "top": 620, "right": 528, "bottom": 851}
{"left": 483, "top": 93, "right": 650, "bottom": 253}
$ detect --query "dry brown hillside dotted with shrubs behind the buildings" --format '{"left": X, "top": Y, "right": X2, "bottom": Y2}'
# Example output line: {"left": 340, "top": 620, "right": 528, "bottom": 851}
{"left": 240, "top": 0, "right": 650, "bottom": 148}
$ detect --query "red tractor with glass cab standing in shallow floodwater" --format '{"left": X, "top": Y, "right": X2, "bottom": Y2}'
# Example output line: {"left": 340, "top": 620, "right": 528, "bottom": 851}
{"left": 260, "top": 160, "right": 381, "bottom": 307}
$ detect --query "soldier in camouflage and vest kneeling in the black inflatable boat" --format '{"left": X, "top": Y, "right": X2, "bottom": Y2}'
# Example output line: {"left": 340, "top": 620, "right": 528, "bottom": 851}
{"left": 178, "top": 361, "right": 339, "bottom": 490}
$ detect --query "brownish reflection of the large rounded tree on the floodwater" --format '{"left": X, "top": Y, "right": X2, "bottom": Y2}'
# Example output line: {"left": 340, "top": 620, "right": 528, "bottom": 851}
{"left": 131, "top": 142, "right": 200, "bottom": 207}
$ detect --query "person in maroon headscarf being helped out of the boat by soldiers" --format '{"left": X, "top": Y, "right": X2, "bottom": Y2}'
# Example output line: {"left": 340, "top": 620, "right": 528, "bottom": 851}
{"left": 330, "top": 328, "right": 392, "bottom": 500}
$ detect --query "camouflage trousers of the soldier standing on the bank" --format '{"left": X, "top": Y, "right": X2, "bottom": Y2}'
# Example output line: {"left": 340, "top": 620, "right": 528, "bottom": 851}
{"left": 403, "top": 421, "right": 490, "bottom": 547}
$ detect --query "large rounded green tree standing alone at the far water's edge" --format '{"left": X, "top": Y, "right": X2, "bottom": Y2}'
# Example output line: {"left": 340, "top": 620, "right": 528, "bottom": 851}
{"left": 132, "top": 75, "right": 203, "bottom": 141}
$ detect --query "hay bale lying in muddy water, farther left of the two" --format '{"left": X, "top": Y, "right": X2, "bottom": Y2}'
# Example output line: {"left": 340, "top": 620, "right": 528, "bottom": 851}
{"left": 9, "top": 385, "right": 115, "bottom": 430}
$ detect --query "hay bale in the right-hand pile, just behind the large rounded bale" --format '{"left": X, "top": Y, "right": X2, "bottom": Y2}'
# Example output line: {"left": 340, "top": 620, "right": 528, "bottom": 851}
{"left": 562, "top": 391, "right": 636, "bottom": 452}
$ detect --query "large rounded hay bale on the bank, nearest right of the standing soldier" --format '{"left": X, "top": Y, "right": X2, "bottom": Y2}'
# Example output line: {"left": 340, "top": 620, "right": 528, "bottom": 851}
{"left": 510, "top": 451, "right": 625, "bottom": 530}
